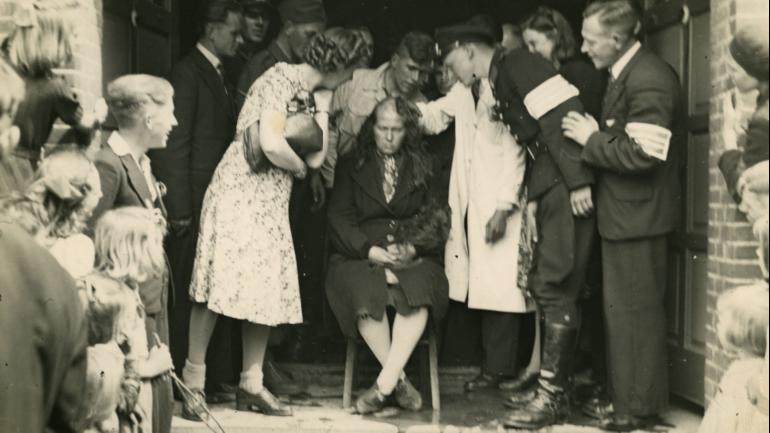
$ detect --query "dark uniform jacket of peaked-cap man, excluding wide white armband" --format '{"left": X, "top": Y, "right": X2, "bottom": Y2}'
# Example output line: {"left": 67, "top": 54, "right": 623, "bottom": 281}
{"left": 490, "top": 48, "right": 594, "bottom": 200}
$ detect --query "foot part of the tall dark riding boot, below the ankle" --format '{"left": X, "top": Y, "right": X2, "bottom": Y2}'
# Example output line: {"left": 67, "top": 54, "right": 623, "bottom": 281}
{"left": 502, "top": 387, "right": 569, "bottom": 430}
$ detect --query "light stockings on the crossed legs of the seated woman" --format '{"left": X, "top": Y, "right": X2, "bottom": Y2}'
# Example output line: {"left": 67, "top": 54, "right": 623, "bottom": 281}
{"left": 358, "top": 308, "right": 428, "bottom": 395}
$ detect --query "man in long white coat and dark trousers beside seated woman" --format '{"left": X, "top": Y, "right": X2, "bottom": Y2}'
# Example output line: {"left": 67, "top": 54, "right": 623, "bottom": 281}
{"left": 417, "top": 60, "right": 529, "bottom": 391}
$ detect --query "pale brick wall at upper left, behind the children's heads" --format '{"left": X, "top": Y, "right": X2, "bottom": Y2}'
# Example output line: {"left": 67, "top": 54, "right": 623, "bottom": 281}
{"left": 0, "top": 0, "right": 102, "bottom": 152}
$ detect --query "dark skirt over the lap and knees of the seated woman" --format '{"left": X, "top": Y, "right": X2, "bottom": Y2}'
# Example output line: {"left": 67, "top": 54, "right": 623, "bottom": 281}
{"left": 326, "top": 254, "right": 449, "bottom": 337}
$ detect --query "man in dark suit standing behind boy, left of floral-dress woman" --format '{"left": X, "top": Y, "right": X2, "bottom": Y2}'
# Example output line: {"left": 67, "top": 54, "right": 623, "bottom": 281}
{"left": 151, "top": 0, "right": 243, "bottom": 404}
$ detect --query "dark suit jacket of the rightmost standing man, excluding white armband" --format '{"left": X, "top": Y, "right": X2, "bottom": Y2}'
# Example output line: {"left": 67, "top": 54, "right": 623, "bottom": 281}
{"left": 582, "top": 47, "right": 685, "bottom": 240}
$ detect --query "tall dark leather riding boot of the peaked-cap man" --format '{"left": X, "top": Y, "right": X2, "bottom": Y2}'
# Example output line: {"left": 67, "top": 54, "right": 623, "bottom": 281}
{"left": 503, "top": 323, "right": 577, "bottom": 430}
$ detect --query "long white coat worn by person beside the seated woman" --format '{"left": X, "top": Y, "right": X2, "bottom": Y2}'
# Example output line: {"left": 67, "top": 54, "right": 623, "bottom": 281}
{"left": 417, "top": 79, "right": 527, "bottom": 313}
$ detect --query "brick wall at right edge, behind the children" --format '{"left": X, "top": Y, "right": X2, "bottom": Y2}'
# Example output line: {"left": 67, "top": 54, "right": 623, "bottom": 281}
{"left": 705, "top": 0, "right": 768, "bottom": 402}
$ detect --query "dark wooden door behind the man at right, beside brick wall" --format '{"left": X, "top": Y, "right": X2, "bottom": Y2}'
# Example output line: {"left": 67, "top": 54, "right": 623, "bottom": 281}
{"left": 645, "top": 0, "right": 711, "bottom": 405}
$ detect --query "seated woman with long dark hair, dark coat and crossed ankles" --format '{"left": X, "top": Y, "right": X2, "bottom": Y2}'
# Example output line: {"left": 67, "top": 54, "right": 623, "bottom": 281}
{"left": 326, "top": 98, "right": 449, "bottom": 413}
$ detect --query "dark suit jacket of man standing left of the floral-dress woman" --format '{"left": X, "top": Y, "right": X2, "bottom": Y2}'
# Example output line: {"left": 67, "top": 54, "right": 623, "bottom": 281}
{"left": 150, "top": 48, "right": 237, "bottom": 221}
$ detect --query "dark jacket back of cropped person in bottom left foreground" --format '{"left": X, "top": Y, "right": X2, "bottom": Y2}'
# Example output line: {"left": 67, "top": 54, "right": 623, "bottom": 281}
{"left": 0, "top": 223, "right": 88, "bottom": 433}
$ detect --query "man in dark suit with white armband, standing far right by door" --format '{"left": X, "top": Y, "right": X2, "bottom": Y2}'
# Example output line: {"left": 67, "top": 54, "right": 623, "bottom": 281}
{"left": 562, "top": 0, "right": 683, "bottom": 431}
